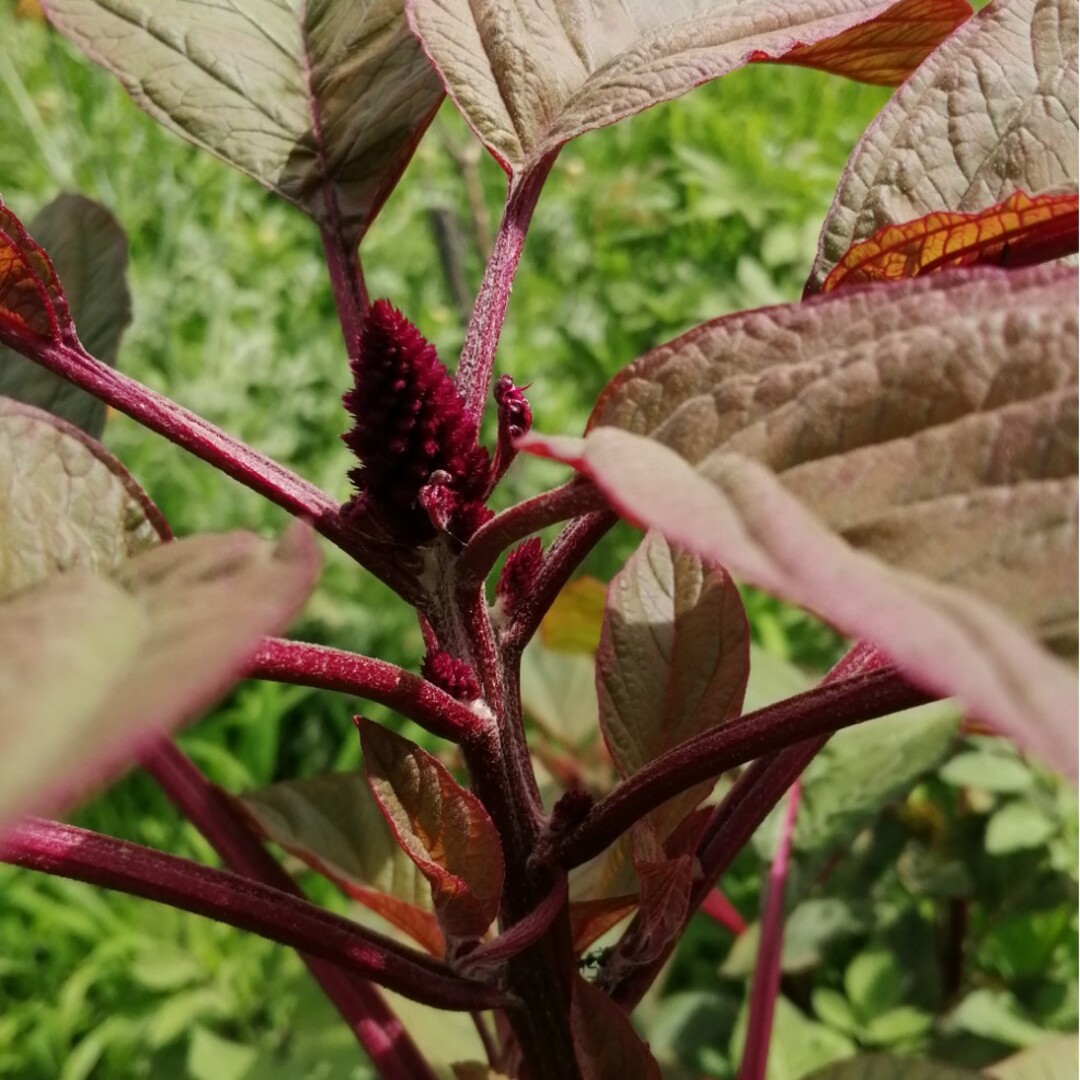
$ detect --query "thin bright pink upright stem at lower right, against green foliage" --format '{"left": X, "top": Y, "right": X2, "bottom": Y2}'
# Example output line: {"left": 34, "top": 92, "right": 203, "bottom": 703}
{"left": 739, "top": 781, "right": 800, "bottom": 1080}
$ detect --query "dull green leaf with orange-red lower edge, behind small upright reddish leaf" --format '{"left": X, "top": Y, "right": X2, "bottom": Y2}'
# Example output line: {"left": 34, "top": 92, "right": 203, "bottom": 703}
{"left": 240, "top": 772, "right": 444, "bottom": 956}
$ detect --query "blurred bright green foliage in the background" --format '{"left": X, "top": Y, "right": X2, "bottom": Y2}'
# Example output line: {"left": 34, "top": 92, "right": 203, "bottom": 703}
{"left": 0, "top": 8, "right": 1077, "bottom": 1080}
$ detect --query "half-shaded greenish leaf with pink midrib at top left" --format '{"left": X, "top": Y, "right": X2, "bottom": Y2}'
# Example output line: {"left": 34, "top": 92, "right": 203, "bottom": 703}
{"left": 45, "top": 0, "right": 442, "bottom": 241}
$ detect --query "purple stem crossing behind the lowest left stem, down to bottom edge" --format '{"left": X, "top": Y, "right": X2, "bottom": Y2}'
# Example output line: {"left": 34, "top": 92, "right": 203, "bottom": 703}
{"left": 143, "top": 739, "right": 435, "bottom": 1080}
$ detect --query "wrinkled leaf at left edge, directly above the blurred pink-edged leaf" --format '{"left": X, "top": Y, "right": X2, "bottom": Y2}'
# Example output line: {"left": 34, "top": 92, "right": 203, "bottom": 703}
{"left": 0, "top": 399, "right": 168, "bottom": 596}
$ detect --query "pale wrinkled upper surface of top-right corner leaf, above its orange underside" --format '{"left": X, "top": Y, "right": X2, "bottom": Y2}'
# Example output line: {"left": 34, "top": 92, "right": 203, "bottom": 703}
{"left": 807, "top": 0, "right": 1077, "bottom": 293}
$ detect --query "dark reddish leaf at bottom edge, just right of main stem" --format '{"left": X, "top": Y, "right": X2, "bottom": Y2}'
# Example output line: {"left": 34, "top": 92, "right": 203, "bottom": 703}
{"left": 570, "top": 976, "right": 663, "bottom": 1080}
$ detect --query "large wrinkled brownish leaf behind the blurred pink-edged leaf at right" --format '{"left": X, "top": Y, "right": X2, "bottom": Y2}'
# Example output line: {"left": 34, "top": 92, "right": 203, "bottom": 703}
{"left": 590, "top": 267, "right": 1077, "bottom": 651}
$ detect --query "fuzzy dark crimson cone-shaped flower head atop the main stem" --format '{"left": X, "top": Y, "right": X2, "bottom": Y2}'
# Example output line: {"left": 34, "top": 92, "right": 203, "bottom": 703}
{"left": 342, "top": 300, "right": 490, "bottom": 544}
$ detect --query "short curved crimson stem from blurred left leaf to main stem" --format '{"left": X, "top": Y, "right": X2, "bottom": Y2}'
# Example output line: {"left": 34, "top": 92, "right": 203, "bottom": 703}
{"left": 244, "top": 637, "right": 487, "bottom": 742}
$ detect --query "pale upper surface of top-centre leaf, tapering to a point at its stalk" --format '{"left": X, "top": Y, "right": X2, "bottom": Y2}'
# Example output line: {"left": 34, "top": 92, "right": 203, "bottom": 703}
{"left": 406, "top": 0, "right": 959, "bottom": 179}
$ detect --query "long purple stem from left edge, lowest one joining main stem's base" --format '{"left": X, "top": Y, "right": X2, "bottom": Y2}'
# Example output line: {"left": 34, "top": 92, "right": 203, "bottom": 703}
{"left": 0, "top": 818, "right": 505, "bottom": 1010}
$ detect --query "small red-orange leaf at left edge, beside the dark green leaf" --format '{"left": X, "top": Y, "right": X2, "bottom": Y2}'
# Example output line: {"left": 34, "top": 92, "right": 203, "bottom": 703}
{"left": 0, "top": 196, "right": 72, "bottom": 341}
